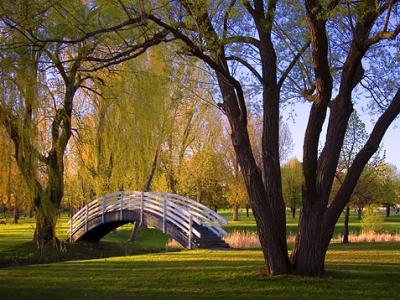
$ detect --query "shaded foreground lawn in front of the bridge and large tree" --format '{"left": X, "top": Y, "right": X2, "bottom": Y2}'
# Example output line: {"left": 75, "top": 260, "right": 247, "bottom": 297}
{"left": 0, "top": 244, "right": 400, "bottom": 299}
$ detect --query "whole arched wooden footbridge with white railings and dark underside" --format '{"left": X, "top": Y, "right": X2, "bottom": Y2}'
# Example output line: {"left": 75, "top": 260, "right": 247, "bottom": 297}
{"left": 68, "top": 191, "right": 229, "bottom": 249}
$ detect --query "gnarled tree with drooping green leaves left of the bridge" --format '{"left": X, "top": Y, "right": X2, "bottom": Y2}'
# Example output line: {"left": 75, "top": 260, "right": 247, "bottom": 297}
{"left": 0, "top": 0, "right": 165, "bottom": 247}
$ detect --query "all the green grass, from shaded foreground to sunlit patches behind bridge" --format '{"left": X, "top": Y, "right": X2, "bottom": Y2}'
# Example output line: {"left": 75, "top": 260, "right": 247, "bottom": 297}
{"left": 0, "top": 212, "right": 400, "bottom": 300}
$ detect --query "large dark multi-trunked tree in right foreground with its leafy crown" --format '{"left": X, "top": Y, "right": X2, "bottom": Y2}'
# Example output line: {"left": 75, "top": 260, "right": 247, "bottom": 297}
{"left": 132, "top": 0, "right": 400, "bottom": 276}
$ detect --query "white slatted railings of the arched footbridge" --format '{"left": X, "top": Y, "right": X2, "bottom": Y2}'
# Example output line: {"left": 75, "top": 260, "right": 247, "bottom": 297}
{"left": 68, "top": 192, "right": 226, "bottom": 245}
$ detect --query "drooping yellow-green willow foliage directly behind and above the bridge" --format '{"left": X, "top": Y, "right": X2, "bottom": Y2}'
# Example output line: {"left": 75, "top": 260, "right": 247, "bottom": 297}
{"left": 77, "top": 48, "right": 179, "bottom": 197}
